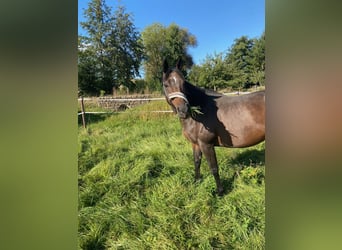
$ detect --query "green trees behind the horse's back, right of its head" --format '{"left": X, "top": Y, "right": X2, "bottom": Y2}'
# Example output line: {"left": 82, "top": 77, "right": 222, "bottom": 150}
{"left": 188, "top": 33, "right": 265, "bottom": 90}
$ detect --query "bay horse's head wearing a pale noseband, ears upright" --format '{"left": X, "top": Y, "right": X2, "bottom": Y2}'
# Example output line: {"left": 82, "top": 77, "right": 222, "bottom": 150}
{"left": 163, "top": 60, "right": 189, "bottom": 119}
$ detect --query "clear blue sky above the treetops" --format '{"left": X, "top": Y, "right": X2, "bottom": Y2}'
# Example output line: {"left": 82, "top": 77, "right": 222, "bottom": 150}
{"left": 78, "top": 0, "right": 265, "bottom": 64}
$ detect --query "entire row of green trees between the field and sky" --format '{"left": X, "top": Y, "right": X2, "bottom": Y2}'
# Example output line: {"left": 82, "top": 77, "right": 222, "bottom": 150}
{"left": 78, "top": 0, "right": 265, "bottom": 95}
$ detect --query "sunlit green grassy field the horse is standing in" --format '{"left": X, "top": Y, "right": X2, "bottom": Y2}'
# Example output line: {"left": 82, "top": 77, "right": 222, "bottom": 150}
{"left": 78, "top": 101, "right": 265, "bottom": 249}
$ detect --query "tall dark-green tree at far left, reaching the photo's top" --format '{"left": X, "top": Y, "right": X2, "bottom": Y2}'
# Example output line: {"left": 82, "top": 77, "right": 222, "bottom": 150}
{"left": 79, "top": 0, "right": 143, "bottom": 94}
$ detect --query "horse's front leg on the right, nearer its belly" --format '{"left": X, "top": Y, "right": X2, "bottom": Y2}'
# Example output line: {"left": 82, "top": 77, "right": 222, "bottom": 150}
{"left": 200, "top": 143, "right": 223, "bottom": 196}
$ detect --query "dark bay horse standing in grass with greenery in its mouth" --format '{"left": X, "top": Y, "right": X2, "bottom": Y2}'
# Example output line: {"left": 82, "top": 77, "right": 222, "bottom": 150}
{"left": 162, "top": 61, "right": 265, "bottom": 195}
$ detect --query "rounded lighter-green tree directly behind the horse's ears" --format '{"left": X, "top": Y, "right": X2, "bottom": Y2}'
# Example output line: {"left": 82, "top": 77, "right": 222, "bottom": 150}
{"left": 142, "top": 23, "right": 197, "bottom": 89}
